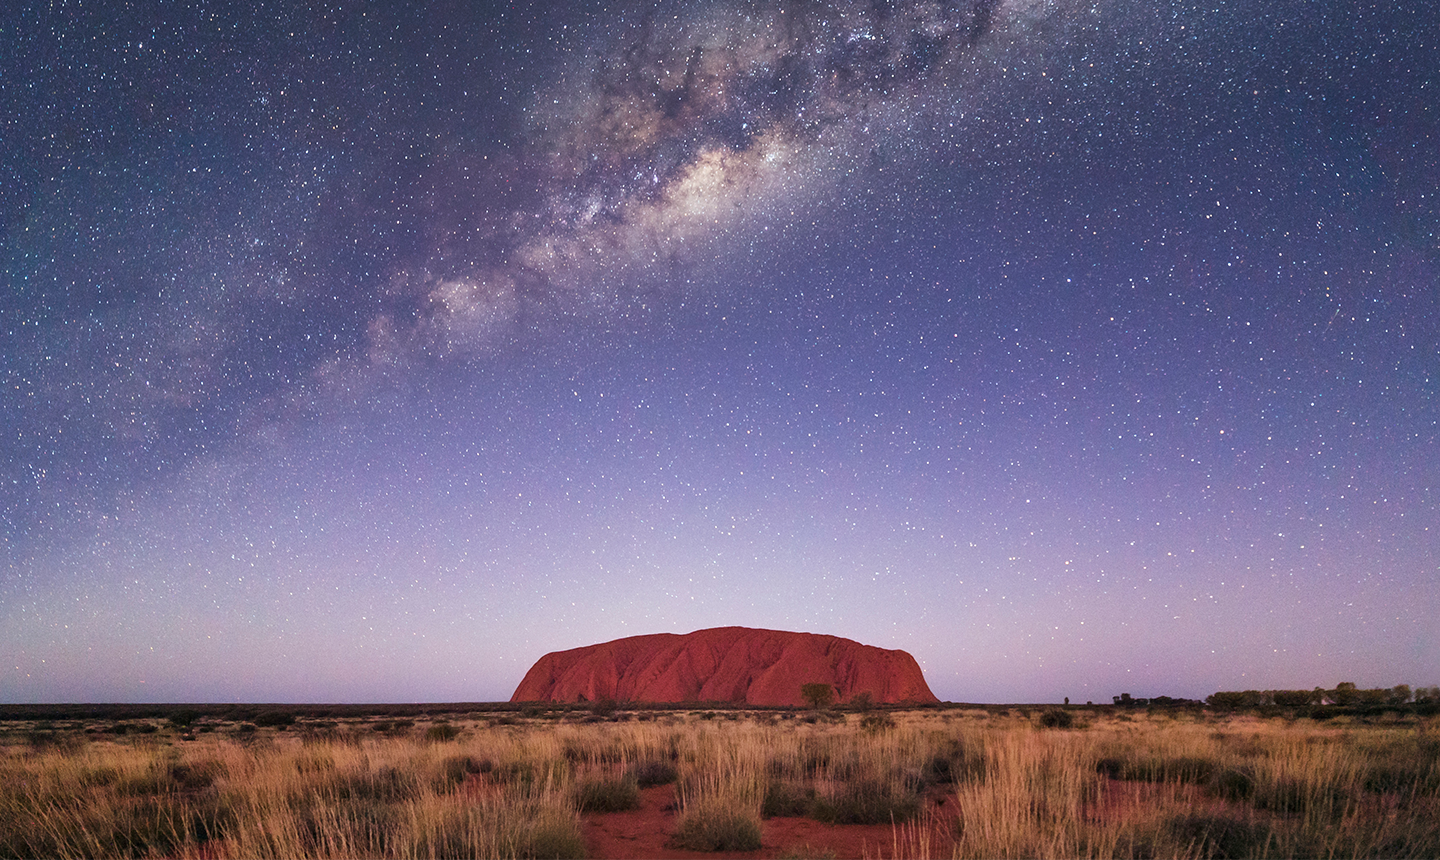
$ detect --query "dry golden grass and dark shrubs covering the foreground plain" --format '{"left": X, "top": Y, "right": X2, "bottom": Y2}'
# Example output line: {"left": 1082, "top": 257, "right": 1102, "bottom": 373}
{"left": 0, "top": 709, "right": 1440, "bottom": 857}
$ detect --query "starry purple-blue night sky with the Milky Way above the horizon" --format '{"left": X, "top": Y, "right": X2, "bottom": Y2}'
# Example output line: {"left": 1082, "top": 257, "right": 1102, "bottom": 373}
{"left": 0, "top": 0, "right": 1440, "bottom": 703}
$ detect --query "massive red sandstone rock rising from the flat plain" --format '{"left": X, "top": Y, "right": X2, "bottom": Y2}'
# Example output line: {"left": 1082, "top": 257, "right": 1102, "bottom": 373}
{"left": 510, "top": 627, "right": 939, "bottom": 706}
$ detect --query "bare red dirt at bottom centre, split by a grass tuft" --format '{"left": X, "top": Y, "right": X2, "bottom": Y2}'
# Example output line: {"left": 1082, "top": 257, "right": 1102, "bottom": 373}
{"left": 585, "top": 785, "right": 955, "bottom": 860}
